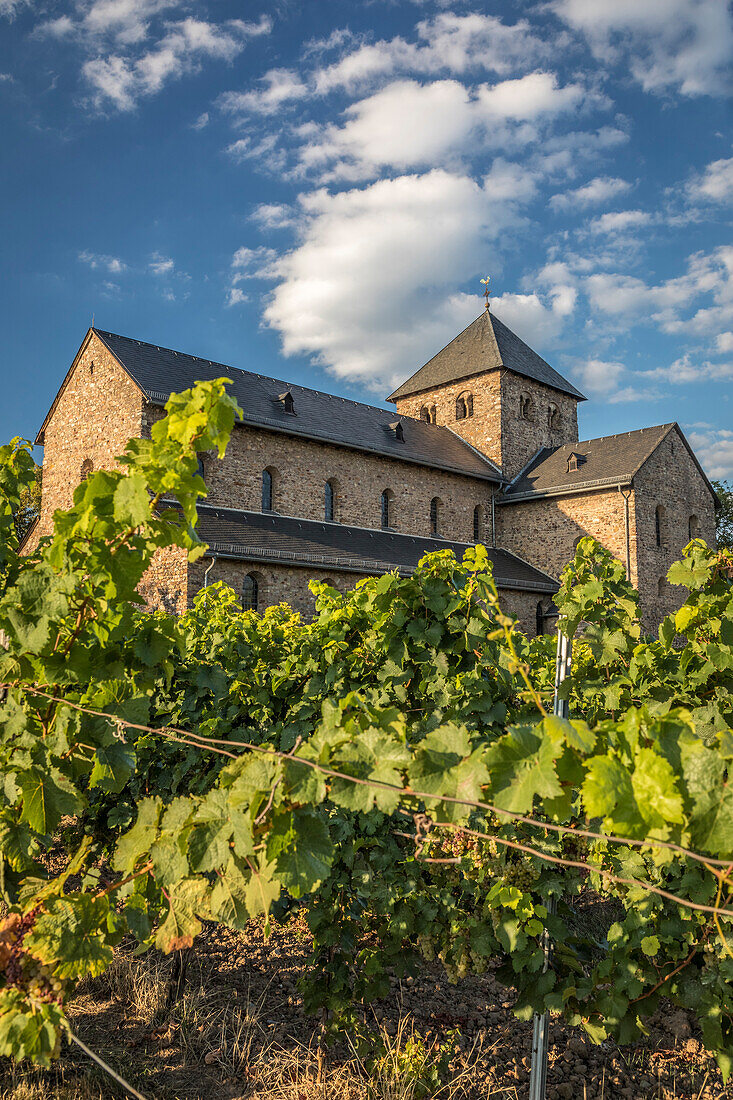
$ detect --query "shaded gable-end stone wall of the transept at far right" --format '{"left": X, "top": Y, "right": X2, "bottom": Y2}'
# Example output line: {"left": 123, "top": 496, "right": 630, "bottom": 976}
{"left": 634, "top": 428, "right": 715, "bottom": 630}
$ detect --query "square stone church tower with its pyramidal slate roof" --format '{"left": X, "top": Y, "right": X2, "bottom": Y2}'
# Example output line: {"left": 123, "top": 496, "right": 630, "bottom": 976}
{"left": 387, "top": 307, "right": 586, "bottom": 481}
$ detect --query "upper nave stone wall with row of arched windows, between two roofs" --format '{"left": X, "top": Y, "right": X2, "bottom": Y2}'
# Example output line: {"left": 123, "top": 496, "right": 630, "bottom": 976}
{"left": 195, "top": 425, "right": 492, "bottom": 542}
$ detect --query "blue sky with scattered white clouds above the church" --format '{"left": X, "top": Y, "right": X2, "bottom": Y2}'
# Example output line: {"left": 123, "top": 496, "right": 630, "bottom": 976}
{"left": 0, "top": 0, "right": 733, "bottom": 477}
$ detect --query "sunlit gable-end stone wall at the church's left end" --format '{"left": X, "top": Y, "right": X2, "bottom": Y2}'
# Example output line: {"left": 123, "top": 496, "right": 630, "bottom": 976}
{"left": 33, "top": 333, "right": 143, "bottom": 540}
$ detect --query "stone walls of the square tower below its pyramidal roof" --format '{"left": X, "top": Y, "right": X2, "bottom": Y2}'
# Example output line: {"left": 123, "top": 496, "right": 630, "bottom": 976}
{"left": 395, "top": 370, "right": 578, "bottom": 479}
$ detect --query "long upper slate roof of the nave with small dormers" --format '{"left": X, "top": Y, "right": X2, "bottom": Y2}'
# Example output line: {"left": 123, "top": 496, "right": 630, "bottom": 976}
{"left": 84, "top": 329, "right": 503, "bottom": 482}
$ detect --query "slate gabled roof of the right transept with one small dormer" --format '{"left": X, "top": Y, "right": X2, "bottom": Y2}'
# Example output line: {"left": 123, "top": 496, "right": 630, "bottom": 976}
{"left": 496, "top": 422, "right": 715, "bottom": 504}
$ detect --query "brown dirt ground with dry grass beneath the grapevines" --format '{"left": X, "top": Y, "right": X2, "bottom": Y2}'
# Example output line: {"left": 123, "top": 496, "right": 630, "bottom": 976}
{"left": 0, "top": 921, "right": 733, "bottom": 1100}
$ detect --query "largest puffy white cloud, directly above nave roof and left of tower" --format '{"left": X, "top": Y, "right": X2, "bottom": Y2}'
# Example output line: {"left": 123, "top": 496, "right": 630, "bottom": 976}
{"left": 259, "top": 165, "right": 539, "bottom": 388}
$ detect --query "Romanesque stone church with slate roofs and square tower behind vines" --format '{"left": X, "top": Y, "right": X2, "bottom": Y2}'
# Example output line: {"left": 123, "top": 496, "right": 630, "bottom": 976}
{"left": 26, "top": 309, "right": 715, "bottom": 634}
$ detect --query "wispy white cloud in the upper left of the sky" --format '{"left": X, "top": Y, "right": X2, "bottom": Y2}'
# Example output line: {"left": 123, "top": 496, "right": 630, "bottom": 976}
{"left": 83, "top": 17, "right": 272, "bottom": 111}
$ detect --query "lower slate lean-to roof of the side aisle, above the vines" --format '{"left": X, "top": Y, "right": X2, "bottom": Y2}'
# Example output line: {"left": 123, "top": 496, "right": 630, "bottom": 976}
{"left": 197, "top": 504, "right": 557, "bottom": 593}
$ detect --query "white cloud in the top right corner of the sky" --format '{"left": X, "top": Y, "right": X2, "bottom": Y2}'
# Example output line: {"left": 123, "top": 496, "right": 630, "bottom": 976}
{"left": 551, "top": 0, "right": 733, "bottom": 96}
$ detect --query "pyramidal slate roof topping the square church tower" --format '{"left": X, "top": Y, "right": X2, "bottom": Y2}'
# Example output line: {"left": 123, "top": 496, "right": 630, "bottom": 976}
{"left": 387, "top": 309, "right": 586, "bottom": 402}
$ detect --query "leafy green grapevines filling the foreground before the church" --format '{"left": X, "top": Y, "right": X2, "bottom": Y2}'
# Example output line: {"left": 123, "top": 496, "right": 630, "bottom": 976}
{"left": 0, "top": 382, "right": 733, "bottom": 1096}
